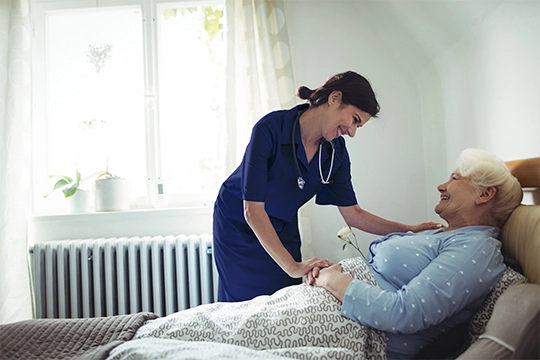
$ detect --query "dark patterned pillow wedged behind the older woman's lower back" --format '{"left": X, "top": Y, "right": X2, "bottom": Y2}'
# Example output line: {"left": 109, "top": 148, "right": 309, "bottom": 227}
{"left": 469, "top": 267, "right": 529, "bottom": 344}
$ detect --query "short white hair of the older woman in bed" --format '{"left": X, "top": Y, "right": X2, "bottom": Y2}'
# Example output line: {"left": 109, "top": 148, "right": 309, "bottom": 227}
{"left": 457, "top": 149, "right": 523, "bottom": 227}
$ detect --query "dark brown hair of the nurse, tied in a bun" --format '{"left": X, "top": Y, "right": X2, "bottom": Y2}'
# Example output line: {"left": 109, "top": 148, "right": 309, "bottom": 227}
{"left": 296, "top": 71, "right": 381, "bottom": 117}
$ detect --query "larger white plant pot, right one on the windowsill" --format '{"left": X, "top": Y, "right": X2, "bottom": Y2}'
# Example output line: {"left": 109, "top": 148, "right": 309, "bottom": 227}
{"left": 95, "top": 178, "right": 130, "bottom": 211}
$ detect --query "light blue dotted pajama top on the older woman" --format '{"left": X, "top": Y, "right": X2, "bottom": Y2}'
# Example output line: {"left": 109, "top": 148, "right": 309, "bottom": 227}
{"left": 341, "top": 226, "right": 505, "bottom": 359}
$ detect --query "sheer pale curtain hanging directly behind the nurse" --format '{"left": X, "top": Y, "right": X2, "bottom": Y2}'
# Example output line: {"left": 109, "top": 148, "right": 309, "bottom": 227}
{"left": 226, "top": 0, "right": 313, "bottom": 258}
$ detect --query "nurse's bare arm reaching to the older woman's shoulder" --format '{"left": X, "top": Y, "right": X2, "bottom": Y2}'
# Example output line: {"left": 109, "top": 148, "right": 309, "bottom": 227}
{"left": 338, "top": 204, "right": 442, "bottom": 235}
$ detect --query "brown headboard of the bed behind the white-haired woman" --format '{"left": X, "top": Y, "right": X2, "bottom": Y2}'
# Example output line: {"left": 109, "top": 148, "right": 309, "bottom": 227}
{"left": 501, "top": 157, "right": 540, "bottom": 284}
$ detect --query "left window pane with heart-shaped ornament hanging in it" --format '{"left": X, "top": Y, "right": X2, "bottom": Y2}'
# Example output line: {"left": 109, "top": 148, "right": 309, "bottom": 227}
{"left": 46, "top": 7, "right": 146, "bottom": 196}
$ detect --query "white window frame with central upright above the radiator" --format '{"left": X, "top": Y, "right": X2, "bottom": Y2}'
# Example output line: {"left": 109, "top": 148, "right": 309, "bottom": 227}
{"left": 31, "top": 0, "right": 228, "bottom": 214}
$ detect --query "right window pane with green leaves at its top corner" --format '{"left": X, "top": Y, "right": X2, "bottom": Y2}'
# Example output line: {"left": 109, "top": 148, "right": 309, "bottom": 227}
{"left": 158, "top": 6, "right": 226, "bottom": 200}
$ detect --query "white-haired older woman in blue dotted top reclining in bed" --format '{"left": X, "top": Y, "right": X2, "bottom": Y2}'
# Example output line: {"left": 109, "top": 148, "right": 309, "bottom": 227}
{"left": 306, "top": 149, "right": 523, "bottom": 358}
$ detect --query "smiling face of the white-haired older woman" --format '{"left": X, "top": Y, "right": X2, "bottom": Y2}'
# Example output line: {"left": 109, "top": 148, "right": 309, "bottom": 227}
{"left": 435, "top": 171, "right": 479, "bottom": 223}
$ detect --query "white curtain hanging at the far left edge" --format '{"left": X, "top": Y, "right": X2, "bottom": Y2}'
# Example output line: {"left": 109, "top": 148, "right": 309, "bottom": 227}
{"left": 0, "top": 0, "right": 32, "bottom": 324}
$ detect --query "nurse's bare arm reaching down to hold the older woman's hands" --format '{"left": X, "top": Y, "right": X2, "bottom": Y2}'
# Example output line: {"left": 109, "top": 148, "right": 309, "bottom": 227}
{"left": 244, "top": 201, "right": 332, "bottom": 278}
